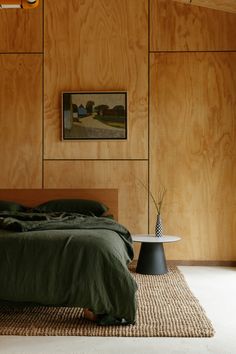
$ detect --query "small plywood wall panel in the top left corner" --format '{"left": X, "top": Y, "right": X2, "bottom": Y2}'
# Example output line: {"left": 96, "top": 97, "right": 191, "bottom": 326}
{"left": 0, "top": 0, "right": 43, "bottom": 53}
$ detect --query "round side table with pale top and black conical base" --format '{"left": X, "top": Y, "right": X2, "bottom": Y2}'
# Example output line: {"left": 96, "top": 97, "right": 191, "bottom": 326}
{"left": 132, "top": 234, "right": 181, "bottom": 275}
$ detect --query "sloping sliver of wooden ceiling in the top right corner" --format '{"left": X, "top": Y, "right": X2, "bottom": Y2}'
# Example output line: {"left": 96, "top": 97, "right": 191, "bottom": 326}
{"left": 172, "top": 0, "right": 236, "bottom": 13}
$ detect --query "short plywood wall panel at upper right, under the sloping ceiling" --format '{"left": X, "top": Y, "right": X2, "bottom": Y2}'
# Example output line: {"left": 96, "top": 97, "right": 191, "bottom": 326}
{"left": 150, "top": 0, "right": 236, "bottom": 51}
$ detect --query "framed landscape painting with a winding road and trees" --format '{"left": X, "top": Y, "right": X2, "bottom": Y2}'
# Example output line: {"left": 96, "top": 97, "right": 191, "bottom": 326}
{"left": 62, "top": 91, "right": 127, "bottom": 140}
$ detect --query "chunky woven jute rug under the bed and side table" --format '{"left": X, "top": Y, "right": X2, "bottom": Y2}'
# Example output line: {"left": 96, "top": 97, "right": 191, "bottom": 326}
{"left": 0, "top": 267, "right": 214, "bottom": 337}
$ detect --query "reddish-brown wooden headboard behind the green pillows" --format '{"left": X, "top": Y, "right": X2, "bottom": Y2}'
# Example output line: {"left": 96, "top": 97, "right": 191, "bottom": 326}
{"left": 0, "top": 189, "right": 118, "bottom": 220}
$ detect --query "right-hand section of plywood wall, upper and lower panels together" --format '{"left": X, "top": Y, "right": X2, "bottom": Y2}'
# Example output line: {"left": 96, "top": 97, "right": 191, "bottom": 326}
{"left": 150, "top": 0, "right": 236, "bottom": 261}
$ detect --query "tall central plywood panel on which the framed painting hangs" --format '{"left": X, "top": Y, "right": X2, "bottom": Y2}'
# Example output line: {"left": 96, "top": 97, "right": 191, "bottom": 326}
{"left": 45, "top": 0, "right": 148, "bottom": 159}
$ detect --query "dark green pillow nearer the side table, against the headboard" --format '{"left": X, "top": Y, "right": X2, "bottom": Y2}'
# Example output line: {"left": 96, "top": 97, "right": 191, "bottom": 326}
{"left": 35, "top": 199, "right": 108, "bottom": 216}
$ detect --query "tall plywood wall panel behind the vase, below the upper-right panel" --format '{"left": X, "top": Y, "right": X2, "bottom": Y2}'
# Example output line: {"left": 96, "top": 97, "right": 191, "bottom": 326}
{"left": 150, "top": 53, "right": 236, "bottom": 260}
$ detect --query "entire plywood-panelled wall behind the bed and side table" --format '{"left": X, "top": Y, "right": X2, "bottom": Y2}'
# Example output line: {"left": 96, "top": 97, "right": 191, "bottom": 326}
{"left": 0, "top": 0, "right": 236, "bottom": 261}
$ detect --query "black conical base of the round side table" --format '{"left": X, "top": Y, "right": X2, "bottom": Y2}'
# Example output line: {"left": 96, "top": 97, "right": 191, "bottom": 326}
{"left": 136, "top": 242, "right": 168, "bottom": 275}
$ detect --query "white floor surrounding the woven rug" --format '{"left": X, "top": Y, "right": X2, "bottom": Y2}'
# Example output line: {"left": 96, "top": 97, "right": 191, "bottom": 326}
{"left": 0, "top": 267, "right": 236, "bottom": 354}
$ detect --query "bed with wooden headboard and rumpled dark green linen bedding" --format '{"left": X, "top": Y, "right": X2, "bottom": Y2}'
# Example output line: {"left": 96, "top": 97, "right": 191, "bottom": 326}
{"left": 0, "top": 190, "right": 137, "bottom": 324}
